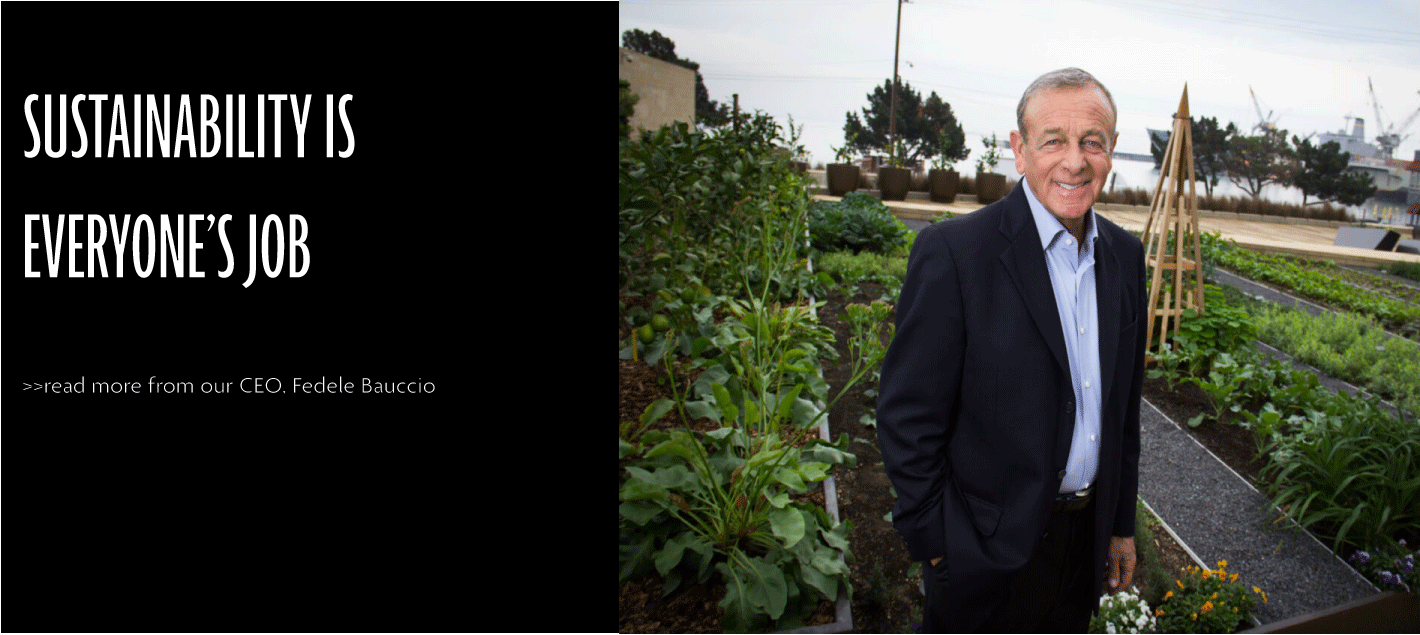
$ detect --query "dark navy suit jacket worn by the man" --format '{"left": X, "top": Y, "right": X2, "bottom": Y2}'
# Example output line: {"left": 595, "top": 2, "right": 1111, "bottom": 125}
{"left": 878, "top": 185, "right": 1147, "bottom": 629}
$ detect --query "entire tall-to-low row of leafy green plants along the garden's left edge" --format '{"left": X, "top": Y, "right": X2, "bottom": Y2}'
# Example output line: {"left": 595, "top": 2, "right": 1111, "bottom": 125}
{"left": 618, "top": 107, "right": 868, "bottom": 631}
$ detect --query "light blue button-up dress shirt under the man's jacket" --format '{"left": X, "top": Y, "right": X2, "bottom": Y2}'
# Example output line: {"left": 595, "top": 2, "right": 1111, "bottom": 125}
{"left": 1021, "top": 179, "right": 1103, "bottom": 493}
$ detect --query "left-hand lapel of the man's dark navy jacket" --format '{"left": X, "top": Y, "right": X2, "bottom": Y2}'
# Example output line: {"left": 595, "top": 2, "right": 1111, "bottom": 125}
{"left": 1001, "top": 185, "right": 1069, "bottom": 376}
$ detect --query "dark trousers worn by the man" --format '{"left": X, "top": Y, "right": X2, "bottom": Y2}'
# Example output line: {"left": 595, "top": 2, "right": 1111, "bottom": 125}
{"left": 922, "top": 501, "right": 1103, "bottom": 634}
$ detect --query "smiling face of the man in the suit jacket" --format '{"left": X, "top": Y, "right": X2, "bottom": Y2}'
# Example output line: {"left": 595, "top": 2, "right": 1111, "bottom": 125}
{"left": 1011, "top": 87, "right": 1119, "bottom": 226}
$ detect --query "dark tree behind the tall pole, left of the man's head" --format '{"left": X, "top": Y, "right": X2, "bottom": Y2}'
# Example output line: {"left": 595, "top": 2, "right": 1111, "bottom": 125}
{"left": 843, "top": 80, "right": 971, "bottom": 163}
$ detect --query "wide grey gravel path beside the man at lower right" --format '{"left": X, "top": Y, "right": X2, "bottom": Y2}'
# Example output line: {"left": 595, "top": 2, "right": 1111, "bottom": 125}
{"left": 1139, "top": 402, "right": 1379, "bottom": 624}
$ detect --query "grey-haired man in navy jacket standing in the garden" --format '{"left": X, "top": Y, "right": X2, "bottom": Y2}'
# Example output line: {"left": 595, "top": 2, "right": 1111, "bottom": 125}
{"left": 878, "top": 68, "right": 1147, "bottom": 632}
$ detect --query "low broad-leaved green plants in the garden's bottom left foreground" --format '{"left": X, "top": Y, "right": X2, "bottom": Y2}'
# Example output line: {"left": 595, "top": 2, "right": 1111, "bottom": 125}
{"left": 619, "top": 428, "right": 855, "bottom": 632}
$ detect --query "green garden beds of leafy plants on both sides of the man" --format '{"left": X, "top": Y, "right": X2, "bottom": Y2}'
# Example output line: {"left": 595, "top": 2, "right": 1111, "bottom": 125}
{"left": 618, "top": 115, "right": 1420, "bottom": 632}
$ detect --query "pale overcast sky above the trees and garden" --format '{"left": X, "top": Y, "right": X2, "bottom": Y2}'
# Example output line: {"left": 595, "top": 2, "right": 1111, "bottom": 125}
{"left": 618, "top": 0, "right": 1420, "bottom": 176}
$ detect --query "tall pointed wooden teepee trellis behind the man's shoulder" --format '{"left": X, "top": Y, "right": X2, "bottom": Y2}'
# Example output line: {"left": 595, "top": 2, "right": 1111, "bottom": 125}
{"left": 1140, "top": 84, "right": 1203, "bottom": 358}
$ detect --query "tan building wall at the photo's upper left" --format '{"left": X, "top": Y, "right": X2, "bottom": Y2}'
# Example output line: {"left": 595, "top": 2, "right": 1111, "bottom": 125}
{"left": 616, "top": 47, "right": 696, "bottom": 138}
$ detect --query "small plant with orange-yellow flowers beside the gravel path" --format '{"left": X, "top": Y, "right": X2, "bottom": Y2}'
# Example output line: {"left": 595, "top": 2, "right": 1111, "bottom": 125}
{"left": 1154, "top": 560, "right": 1267, "bottom": 632}
